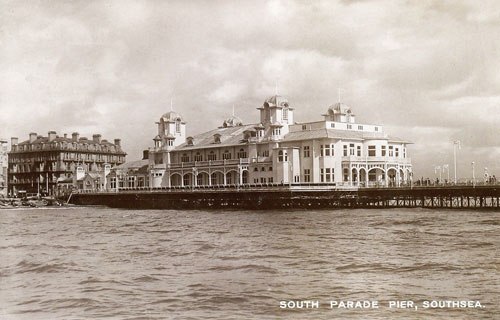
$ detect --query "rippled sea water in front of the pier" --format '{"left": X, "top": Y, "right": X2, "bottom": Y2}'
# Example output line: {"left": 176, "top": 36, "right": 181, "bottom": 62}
{"left": 0, "top": 207, "right": 500, "bottom": 319}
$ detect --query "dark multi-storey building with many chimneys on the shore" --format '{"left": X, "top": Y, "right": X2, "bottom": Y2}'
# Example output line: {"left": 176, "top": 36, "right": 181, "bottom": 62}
{"left": 8, "top": 131, "right": 126, "bottom": 195}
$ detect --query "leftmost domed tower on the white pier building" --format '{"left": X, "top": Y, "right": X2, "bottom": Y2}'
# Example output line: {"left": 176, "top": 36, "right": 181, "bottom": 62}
{"left": 155, "top": 111, "right": 186, "bottom": 150}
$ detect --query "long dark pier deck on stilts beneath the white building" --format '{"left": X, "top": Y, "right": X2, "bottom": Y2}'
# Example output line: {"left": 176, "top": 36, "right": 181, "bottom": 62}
{"left": 68, "top": 184, "right": 500, "bottom": 209}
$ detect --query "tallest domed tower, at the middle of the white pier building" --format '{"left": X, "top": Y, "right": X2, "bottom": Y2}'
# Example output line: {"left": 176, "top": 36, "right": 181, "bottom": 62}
{"left": 257, "top": 95, "right": 293, "bottom": 139}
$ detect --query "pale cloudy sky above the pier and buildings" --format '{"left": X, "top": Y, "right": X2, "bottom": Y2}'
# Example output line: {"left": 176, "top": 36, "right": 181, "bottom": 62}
{"left": 0, "top": 0, "right": 500, "bottom": 178}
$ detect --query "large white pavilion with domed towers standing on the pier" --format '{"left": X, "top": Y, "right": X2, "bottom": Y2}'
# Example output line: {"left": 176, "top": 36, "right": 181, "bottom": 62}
{"left": 148, "top": 95, "right": 412, "bottom": 187}
